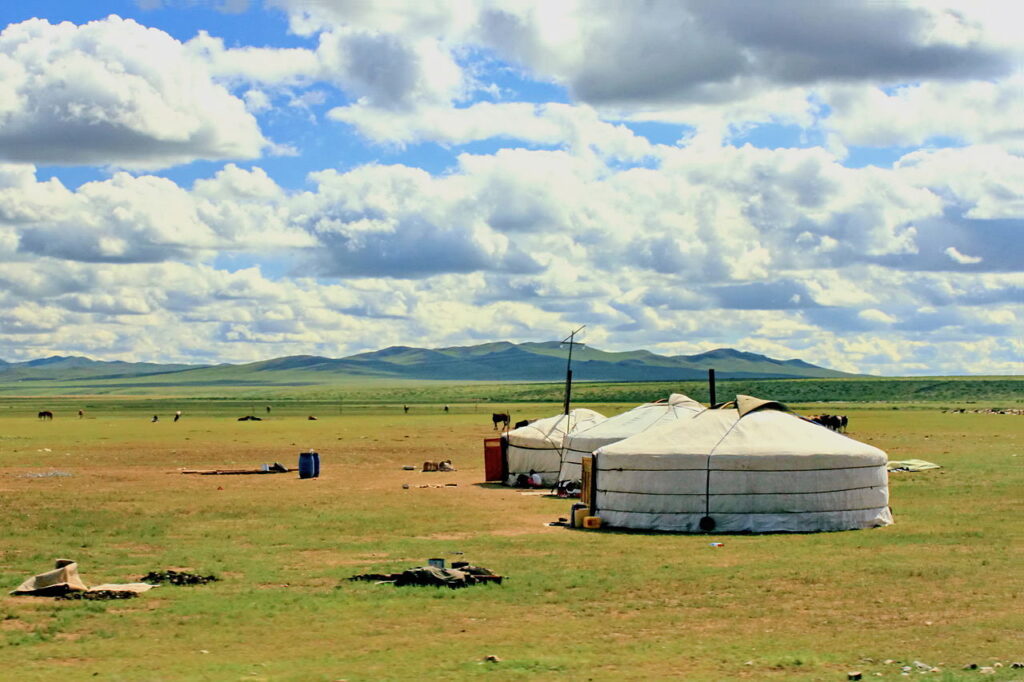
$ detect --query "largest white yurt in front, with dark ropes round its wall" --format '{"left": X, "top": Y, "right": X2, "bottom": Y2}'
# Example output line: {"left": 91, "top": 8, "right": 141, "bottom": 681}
{"left": 591, "top": 395, "right": 893, "bottom": 532}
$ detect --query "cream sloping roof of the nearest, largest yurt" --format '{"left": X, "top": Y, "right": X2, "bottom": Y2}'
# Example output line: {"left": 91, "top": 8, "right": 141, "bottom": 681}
{"left": 598, "top": 395, "right": 887, "bottom": 462}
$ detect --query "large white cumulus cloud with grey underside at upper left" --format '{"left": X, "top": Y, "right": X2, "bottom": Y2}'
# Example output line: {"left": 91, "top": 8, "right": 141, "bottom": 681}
{"left": 0, "top": 15, "right": 267, "bottom": 168}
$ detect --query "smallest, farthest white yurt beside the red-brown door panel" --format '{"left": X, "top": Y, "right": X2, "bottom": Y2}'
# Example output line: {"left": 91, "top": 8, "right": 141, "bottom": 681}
{"left": 505, "top": 409, "right": 605, "bottom": 485}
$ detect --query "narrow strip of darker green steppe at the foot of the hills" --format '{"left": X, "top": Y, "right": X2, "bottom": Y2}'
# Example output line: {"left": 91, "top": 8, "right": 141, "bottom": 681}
{"left": 0, "top": 372, "right": 1024, "bottom": 409}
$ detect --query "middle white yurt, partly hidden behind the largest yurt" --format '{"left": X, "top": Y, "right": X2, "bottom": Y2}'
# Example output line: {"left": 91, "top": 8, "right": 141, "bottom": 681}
{"left": 558, "top": 393, "right": 705, "bottom": 481}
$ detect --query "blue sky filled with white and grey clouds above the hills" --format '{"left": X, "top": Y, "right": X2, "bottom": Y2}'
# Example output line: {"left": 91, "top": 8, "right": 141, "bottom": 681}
{"left": 0, "top": 0, "right": 1024, "bottom": 375}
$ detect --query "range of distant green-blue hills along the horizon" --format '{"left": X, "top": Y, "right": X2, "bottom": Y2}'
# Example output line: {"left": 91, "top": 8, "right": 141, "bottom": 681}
{"left": 0, "top": 341, "right": 857, "bottom": 387}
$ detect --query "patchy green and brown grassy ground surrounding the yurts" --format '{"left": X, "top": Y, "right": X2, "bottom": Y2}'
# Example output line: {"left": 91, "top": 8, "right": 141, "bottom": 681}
{"left": 0, "top": 395, "right": 1024, "bottom": 680}
